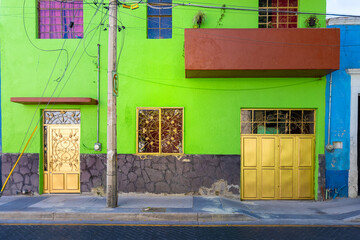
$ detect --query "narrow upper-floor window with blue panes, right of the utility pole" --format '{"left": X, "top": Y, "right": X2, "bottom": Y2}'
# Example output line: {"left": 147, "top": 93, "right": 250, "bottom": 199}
{"left": 147, "top": 0, "right": 172, "bottom": 39}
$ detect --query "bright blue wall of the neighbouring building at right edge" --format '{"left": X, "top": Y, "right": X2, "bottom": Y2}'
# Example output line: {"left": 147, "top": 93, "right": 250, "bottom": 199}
{"left": 325, "top": 25, "right": 360, "bottom": 196}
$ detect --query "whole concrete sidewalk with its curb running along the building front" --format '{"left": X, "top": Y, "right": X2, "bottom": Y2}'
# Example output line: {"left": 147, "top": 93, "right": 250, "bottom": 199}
{"left": 0, "top": 194, "right": 360, "bottom": 225}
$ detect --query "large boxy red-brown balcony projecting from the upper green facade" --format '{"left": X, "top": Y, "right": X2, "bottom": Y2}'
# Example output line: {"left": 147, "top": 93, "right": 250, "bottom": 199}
{"left": 185, "top": 28, "right": 340, "bottom": 78}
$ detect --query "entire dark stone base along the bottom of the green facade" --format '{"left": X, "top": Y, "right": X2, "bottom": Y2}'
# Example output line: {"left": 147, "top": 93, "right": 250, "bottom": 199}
{"left": 1, "top": 153, "right": 325, "bottom": 201}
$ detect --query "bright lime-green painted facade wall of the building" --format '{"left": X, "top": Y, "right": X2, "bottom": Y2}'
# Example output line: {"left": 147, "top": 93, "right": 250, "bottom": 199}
{"left": 0, "top": 0, "right": 326, "bottom": 198}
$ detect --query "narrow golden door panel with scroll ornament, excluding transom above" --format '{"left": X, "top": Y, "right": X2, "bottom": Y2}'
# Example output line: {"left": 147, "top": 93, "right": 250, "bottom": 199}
{"left": 44, "top": 125, "right": 80, "bottom": 193}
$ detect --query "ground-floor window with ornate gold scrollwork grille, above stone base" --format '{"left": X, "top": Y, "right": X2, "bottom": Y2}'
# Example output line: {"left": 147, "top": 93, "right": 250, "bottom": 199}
{"left": 137, "top": 108, "right": 184, "bottom": 154}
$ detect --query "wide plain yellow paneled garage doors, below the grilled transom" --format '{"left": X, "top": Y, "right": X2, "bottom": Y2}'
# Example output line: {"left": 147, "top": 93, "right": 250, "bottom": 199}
{"left": 241, "top": 134, "right": 315, "bottom": 200}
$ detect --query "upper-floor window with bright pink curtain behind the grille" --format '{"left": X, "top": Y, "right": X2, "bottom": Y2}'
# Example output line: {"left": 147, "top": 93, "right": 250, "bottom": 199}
{"left": 38, "top": 0, "right": 83, "bottom": 39}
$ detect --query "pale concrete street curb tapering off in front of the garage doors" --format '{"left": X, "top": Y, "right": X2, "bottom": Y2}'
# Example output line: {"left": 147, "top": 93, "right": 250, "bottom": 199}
{"left": 0, "top": 212, "right": 257, "bottom": 223}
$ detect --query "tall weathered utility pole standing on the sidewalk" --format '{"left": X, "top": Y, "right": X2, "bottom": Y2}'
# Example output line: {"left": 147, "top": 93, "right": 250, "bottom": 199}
{"left": 106, "top": 0, "right": 117, "bottom": 208}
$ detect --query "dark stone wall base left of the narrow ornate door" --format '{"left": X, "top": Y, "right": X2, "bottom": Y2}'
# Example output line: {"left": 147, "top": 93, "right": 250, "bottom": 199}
{"left": 1, "top": 153, "right": 39, "bottom": 195}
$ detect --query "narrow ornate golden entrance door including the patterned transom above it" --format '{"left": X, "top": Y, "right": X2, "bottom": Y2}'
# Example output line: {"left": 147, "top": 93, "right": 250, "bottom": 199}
{"left": 43, "top": 110, "right": 80, "bottom": 193}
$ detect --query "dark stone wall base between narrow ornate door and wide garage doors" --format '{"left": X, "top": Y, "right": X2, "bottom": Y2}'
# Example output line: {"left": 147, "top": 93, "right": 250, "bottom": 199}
{"left": 81, "top": 154, "right": 240, "bottom": 195}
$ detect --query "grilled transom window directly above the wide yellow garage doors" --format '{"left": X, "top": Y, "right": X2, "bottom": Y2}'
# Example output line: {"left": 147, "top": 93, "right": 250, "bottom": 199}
{"left": 241, "top": 109, "right": 315, "bottom": 134}
